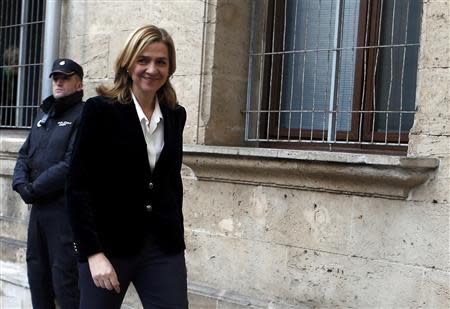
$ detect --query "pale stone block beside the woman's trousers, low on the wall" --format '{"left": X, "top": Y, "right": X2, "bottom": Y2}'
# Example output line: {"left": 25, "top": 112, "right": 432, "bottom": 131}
{"left": 186, "top": 230, "right": 287, "bottom": 300}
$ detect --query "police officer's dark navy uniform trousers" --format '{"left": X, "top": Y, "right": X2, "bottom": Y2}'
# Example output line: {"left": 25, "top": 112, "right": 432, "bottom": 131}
{"left": 27, "top": 205, "right": 79, "bottom": 309}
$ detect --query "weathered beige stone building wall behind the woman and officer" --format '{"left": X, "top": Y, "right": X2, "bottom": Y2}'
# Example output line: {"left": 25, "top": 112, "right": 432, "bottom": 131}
{"left": 0, "top": 0, "right": 450, "bottom": 308}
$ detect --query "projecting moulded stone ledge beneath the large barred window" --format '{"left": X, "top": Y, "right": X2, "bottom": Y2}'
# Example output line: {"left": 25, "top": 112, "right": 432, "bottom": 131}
{"left": 184, "top": 145, "right": 439, "bottom": 199}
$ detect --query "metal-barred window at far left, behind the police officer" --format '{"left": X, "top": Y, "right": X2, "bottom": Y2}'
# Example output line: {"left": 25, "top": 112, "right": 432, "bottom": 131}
{"left": 0, "top": 0, "right": 45, "bottom": 128}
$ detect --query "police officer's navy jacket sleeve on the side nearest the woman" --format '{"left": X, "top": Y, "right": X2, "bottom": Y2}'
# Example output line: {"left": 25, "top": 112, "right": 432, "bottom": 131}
{"left": 32, "top": 121, "right": 79, "bottom": 198}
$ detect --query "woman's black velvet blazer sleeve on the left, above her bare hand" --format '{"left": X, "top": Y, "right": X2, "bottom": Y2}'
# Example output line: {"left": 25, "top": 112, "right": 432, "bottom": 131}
{"left": 66, "top": 99, "right": 103, "bottom": 261}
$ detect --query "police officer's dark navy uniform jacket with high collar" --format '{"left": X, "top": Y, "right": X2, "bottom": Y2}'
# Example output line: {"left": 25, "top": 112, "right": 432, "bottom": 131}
{"left": 12, "top": 91, "right": 83, "bottom": 207}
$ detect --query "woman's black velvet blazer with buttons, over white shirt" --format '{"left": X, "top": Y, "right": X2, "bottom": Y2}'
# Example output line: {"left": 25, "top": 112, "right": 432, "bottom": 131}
{"left": 66, "top": 96, "right": 186, "bottom": 261}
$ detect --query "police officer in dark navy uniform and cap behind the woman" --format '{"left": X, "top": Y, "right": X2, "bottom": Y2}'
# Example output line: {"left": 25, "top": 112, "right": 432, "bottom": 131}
{"left": 12, "top": 59, "right": 83, "bottom": 309}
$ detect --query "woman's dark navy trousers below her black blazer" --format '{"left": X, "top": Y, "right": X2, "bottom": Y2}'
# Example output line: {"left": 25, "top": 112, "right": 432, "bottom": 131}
{"left": 78, "top": 237, "right": 188, "bottom": 309}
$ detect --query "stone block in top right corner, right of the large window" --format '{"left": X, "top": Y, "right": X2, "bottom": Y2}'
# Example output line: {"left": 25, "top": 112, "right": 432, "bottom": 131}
{"left": 419, "top": 1, "right": 450, "bottom": 68}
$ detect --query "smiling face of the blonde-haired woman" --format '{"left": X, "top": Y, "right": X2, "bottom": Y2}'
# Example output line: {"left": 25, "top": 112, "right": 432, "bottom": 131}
{"left": 128, "top": 42, "right": 169, "bottom": 96}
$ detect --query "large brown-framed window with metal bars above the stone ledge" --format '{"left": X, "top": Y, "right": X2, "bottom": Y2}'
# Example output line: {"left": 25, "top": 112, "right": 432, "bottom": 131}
{"left": 246, "top": 0, "right": 422, "bottom": 151}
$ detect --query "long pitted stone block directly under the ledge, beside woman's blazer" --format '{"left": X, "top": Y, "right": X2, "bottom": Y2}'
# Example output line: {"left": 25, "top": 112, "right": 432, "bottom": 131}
{"left": 184, "top": 181, "right": 352, "bottom": 253}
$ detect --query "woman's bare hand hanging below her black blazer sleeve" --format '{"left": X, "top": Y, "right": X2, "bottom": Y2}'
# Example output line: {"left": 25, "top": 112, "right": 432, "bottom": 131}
{"left": 88, "top": 252, "right": 120, "bottom": 293}
